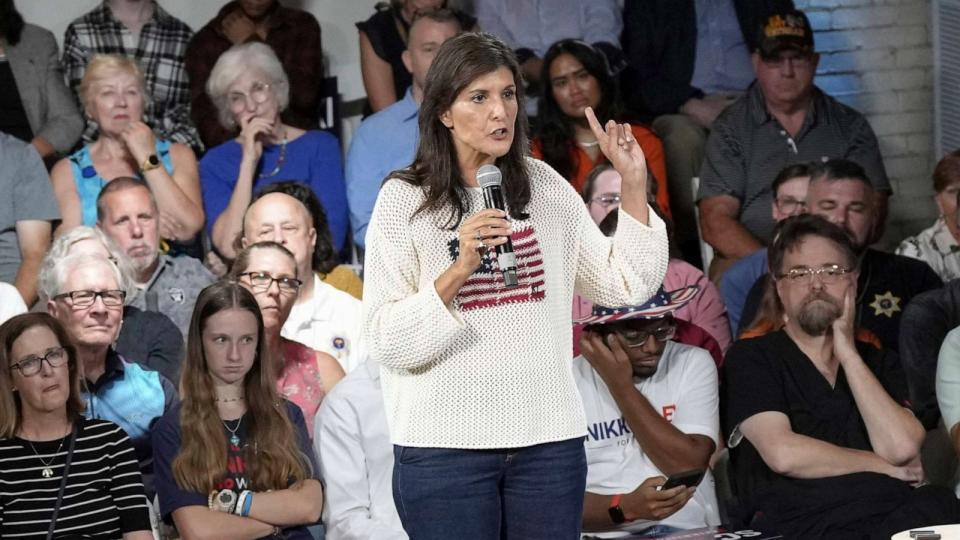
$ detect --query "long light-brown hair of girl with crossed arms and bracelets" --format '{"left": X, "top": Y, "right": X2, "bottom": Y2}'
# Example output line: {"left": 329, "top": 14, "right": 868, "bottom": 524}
{"left": 173, "top": 281, "right": 310, "bottom": 493}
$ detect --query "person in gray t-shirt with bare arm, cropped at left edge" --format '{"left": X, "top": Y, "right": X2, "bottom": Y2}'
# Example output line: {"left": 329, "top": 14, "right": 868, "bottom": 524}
{"left": 0, "top": 133, "right": 60, "bottom": 306}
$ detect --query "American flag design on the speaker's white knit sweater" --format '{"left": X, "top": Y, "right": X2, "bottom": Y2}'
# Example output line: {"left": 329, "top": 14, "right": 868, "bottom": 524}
{"left": 447, "top": 225, "right": 546, "bottom": 311}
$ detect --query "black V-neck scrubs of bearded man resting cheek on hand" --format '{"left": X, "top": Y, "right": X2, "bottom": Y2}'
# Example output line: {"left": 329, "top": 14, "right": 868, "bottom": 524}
{"left": 723, "top": 330, "right": 907, "bottom": 532}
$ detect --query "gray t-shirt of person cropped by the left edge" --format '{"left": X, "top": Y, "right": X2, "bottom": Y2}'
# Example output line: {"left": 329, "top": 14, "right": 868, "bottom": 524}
{"left": 0, "top": 133, "right": 60, "bottom": 283}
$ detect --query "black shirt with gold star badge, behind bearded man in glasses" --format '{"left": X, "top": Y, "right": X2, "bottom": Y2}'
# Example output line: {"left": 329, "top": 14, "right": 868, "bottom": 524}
{"left": 740, "top": 249, "right": 943, "bottom": 351}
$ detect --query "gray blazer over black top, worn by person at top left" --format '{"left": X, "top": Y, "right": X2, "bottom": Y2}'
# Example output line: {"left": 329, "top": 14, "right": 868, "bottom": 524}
{"left": 5, "top": 24, "right": 83, "bottom": 154}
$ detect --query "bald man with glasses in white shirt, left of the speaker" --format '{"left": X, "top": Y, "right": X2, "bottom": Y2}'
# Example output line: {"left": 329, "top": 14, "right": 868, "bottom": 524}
{"left": 240, "top": 187, "right": 365, "bottom": 373}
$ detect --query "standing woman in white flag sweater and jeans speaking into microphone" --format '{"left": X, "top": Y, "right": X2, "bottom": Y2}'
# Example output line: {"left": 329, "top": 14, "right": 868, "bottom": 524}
{"left": 363, "top": 34, "right": 667, "bottom": 540}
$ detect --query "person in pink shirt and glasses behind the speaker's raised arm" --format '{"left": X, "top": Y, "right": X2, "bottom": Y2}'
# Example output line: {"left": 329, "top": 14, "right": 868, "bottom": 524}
{"left": 573, "top": 163, "right": 730, "bottom": 358}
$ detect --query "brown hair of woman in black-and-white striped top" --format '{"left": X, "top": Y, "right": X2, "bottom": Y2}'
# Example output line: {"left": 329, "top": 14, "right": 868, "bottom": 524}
{"left": 0, "top": 313, "right": 85, "bottom": 438}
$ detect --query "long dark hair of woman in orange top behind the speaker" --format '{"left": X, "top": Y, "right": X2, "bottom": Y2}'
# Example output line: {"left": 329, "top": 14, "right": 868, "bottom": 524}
{"left": 537, "top": 39, "right": 623, "bottom": 179}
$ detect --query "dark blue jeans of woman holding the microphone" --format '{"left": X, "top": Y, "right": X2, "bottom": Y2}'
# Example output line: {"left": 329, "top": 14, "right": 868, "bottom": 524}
{"left": 393, "top": 438, "right": 587, "bottom": 540}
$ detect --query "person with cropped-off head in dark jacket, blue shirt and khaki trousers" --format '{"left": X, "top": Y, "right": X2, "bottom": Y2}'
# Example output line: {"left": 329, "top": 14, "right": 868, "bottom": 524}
{"left": 621, "top": 0, "right": 793, "bottom": 260}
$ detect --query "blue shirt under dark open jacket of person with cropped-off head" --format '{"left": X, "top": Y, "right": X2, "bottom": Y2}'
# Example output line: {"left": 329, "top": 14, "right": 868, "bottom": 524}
{"left": 690, "top": 0, "right": 753, "bottom": 94}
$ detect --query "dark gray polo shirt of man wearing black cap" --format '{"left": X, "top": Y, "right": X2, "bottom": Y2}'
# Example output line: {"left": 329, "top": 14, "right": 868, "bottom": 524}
{"left": 697, "top": 83, "right": 891, "bottom": 243}
